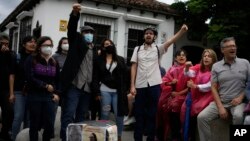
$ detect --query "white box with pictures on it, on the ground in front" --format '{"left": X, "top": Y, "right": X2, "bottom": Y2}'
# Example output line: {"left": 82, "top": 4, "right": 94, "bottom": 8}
{"left": 66, "top": 120, "right": 118, "bottom": 141}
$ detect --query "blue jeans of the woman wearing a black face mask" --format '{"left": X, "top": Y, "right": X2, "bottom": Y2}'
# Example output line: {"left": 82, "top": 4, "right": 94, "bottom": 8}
{"left": 101, "top": 91, "right": 123, "bottom": 136}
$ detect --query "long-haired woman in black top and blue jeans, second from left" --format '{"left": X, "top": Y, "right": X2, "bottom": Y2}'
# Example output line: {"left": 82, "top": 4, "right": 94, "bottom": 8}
{"left": 11, "top": 36, "right": 36, "bottom": 140}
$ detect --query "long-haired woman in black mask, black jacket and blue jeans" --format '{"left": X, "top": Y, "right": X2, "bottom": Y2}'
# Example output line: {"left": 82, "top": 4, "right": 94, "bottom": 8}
{"left": 93, "top": 39, "right": 128, "bottom": 141}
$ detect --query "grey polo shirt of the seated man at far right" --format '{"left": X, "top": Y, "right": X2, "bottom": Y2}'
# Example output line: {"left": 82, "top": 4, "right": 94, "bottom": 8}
{"left": 211, "top": 58, "right": 250, "bottom": 106}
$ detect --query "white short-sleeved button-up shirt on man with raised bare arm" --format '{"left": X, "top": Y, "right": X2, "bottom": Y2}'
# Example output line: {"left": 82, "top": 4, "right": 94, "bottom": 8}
{"left": 131, "top": 43, "right": 167, "bottom": 88}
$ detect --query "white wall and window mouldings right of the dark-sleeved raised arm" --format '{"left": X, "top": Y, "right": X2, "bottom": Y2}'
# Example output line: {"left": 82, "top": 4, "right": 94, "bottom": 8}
{"left": 78, "top": 1, "right": 174, "bottom": 69}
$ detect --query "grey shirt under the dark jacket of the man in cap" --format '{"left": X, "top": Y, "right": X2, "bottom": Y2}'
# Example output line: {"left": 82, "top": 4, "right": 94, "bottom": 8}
{"left": 72, "top": 48, "right": 93, "bottom": 93}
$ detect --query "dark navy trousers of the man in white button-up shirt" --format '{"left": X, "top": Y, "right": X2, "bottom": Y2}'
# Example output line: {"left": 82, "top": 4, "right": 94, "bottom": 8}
{"left": 134, "top": 85, "right": 161, "bottom": 141}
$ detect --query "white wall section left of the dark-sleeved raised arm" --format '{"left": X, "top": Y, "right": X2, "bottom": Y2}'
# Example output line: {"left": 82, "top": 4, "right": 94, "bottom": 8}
{"left": 32, "top": 0, "right": 74, "bottom": 52}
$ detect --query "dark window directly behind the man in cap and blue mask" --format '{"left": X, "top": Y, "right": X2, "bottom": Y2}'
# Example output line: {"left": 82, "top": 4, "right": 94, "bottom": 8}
{"left": 85, "top": 22, "right": 111, "bottom": 47}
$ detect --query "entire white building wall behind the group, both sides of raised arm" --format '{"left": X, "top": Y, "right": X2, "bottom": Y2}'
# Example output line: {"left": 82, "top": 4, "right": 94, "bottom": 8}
{"left": 5, "top": 0, "right": 174, "bottom": 69}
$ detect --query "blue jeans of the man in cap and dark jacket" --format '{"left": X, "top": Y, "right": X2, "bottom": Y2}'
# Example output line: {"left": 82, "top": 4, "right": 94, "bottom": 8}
{"left": 60, "top": 86, "right": 90, "bottom": 141}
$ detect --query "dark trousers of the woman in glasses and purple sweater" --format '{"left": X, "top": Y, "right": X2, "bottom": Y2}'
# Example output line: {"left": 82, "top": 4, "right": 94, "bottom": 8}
{"left": 28, "top": 100, "right": 55, "bottom": 141}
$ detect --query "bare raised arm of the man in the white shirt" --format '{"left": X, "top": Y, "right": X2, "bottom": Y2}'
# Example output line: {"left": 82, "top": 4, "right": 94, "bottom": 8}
{"left": 163, "top": 24, "right": 188, "bottom": 49}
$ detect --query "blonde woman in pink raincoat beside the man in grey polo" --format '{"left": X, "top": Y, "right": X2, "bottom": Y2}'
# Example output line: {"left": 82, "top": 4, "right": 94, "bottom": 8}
{"left": 181, "top": 49, "right": 217, "bottom": 140}
